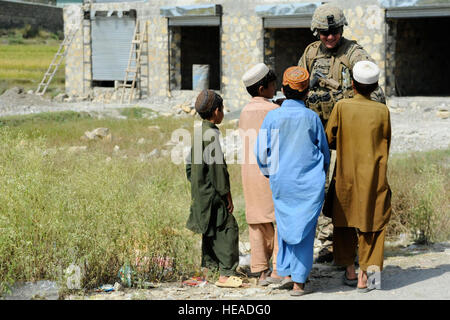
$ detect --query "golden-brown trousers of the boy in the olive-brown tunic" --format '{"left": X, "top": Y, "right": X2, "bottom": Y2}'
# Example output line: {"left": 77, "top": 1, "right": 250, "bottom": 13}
{"left": 333, "top": 227, "right": 386, "bottom": 271}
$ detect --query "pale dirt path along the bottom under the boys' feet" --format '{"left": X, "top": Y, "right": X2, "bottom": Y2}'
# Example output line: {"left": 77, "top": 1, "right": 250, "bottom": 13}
{"left": 66, "top": 242, "right": 450, "bottom": 300}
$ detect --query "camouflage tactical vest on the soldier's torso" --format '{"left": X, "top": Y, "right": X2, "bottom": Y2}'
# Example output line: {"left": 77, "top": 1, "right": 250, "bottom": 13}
{"left": 299, "top": 38, "right": 362, "bottom": 125}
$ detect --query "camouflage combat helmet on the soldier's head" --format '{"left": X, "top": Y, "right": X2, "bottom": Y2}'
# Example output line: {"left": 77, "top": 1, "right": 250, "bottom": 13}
{"left": 311, "top": 3, "right": 348, "bottom": 36}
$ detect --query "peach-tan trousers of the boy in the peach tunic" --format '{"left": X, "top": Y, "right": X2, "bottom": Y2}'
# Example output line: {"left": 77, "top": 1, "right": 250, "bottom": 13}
{"left": 248, "top": 222, "right": 278, "bottom": 272}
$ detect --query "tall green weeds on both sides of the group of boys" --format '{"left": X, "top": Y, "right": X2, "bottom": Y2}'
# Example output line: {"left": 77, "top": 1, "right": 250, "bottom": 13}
{"left": 0, "top": 108, "right": 444, "bottom": 296}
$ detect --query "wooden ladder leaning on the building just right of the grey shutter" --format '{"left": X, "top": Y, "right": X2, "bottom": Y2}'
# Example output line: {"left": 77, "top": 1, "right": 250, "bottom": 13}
{"left": 118, "top": 20, "right": 148, "bottom": 104}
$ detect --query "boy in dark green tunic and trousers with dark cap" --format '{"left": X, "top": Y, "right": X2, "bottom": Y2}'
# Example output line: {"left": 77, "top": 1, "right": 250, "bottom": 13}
{"left": 186, "top": 90, "right": 242, "bottom": 286}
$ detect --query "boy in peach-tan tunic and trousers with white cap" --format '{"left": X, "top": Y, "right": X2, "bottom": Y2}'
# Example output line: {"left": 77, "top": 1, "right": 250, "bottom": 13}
{"left": 239, "top": 63, "right": 281, "bottom": 285}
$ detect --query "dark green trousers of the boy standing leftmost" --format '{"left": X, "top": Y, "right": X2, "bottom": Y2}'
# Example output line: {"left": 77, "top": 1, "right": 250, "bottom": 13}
{"left": 202, "top": 214, "right": 239, "bottom": 276}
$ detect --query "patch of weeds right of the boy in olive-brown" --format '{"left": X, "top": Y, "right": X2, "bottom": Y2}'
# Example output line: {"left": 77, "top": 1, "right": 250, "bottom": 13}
{"left": 388, "top": 149, "right": 450, "bottom": 243}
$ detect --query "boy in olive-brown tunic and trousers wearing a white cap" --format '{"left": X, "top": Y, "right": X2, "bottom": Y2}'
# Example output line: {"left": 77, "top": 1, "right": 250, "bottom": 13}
{"left": 326, "top": 61, "right": 391, "bottom": 292}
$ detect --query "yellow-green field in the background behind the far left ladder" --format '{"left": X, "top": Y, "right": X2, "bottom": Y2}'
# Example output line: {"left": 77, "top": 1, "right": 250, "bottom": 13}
{"left": 0, "top": 29, "right": 65, "bottom": 94}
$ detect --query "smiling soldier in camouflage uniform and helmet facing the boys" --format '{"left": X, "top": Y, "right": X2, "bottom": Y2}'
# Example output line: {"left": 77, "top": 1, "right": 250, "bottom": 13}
{"left": 298, "top": 4, "right": 386, "bottom": 262}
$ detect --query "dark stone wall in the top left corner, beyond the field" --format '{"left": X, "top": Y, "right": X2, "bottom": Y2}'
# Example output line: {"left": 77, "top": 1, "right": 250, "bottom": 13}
{"left": 0, "top": 0, "right": 63, "bottom": 32}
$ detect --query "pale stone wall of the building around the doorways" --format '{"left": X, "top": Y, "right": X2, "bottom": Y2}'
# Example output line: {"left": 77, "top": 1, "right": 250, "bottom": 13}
{"left": 65, "top": 0, "right": 385, "bottom": 110}
